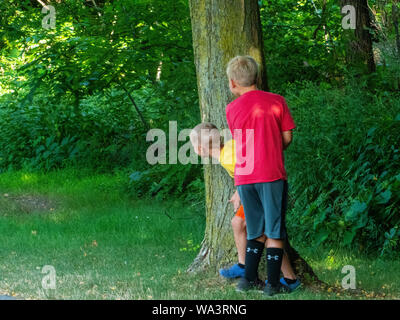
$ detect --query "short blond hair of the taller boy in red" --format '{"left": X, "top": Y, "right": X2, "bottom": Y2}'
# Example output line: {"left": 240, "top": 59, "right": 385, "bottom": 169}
{"left": 226, "top": 56, "right": 259, "bottom": 87}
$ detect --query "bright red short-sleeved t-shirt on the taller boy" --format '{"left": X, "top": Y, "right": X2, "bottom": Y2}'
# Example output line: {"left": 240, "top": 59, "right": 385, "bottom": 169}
{"left": 226, "top": 90, "right": 296, "bottom": 186}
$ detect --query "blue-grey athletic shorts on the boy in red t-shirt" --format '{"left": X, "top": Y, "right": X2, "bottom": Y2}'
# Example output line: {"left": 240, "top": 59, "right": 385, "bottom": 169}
{"left": 238, "top": 180, "right": 288, "bottom": 240}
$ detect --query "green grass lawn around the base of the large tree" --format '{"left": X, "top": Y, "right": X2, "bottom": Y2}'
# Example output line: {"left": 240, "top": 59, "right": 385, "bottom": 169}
{"left": 0, "top": 170, "right": 400, "bottom": 299}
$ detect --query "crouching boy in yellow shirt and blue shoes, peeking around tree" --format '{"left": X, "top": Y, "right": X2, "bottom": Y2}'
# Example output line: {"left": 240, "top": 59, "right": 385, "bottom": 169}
{"left": 190, "top": 122, "right": 300, "bottom": 291}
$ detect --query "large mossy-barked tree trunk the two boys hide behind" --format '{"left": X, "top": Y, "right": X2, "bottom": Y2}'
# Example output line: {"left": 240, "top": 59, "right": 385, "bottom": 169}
{"left": 188, "top": 0, "right": 319, "bottom": 283}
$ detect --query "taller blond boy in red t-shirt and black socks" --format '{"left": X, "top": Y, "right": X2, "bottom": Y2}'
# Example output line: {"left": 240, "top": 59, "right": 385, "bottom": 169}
{"left": 226, "top": 56, "right": 299, "bottom": 296}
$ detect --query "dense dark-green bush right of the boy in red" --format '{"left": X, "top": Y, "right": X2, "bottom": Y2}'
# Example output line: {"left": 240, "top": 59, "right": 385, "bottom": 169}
{"left": 286, "top": 84, "right": 400, "bottom": 253}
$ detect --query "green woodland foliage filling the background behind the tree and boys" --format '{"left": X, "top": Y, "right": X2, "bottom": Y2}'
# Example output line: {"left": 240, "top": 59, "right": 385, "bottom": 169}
{"left": 0, "top": 0, "right": 400, "bottom": 252}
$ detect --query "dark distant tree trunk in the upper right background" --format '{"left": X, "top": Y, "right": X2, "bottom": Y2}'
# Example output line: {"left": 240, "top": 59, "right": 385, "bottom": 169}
{"left": 341, "top": 0, "right": 376, "bottom": 74}
